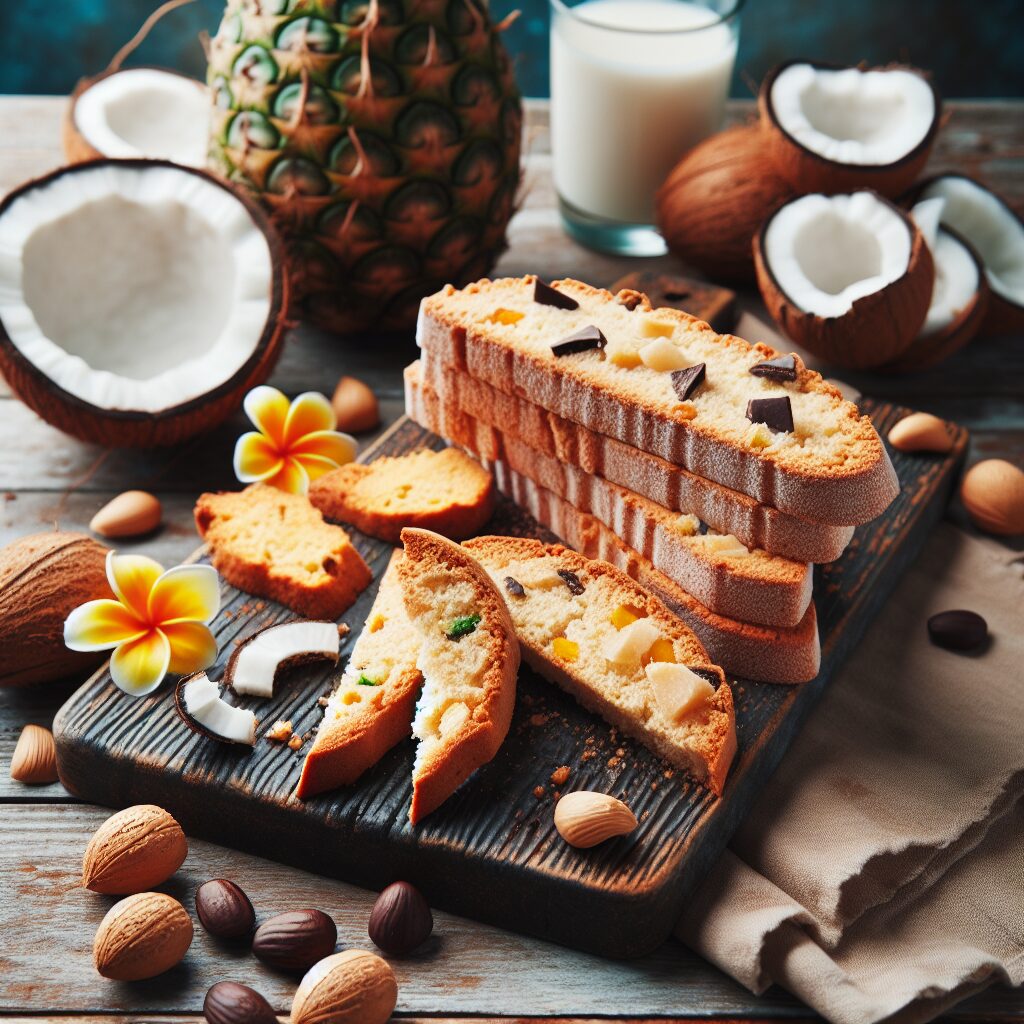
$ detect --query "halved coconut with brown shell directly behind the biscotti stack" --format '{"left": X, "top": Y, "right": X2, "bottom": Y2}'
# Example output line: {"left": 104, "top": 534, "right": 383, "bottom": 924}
{"left": 754, "top": 191, "right": 935, "bottom": 370}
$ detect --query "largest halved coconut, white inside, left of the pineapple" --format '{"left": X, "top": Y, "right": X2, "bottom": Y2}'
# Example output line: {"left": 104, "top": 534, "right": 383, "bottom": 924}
{"left": 0, "top": 160, "right": 288, "bottom": 446}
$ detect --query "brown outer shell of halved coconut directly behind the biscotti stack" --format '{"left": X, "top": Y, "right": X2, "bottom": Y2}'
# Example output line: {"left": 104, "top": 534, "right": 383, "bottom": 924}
{"left": 754, "top": 197, "right": 935, "bottom": 370}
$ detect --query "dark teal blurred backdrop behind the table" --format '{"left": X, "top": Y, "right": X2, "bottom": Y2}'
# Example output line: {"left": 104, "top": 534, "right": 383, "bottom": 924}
{"left": 0, "top": 0, "right": 1024, "bottom": 97}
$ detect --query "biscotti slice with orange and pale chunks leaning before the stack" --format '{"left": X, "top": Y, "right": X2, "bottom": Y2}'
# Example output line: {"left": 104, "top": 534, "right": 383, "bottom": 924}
{"left": 464, "top": 537, "right": 736, "bottom": 794}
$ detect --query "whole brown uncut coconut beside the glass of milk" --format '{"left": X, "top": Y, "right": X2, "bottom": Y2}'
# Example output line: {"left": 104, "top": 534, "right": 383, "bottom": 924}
{"left": 656, "top": 124, "right": 796, "bottom": 282}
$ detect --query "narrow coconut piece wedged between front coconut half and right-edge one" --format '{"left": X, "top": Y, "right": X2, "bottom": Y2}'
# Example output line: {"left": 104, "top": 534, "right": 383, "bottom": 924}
{"left": 885, "top": 199, "right": 988, "bottom": 371}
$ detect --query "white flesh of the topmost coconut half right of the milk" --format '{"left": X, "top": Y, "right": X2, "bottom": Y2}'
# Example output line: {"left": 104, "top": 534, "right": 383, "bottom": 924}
{"left": 771, "top": 63, "right": 935, "bottom": 167}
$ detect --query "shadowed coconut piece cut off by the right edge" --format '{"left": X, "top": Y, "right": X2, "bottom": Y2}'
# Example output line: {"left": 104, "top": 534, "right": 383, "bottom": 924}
{"left": 913, "top": 174, "right": 1024, "bottom": 334}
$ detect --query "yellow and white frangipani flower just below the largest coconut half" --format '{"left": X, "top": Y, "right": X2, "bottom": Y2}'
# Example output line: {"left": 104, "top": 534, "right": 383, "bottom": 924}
{"left": 234, "top": 385, "right": 355, "bottom": 495}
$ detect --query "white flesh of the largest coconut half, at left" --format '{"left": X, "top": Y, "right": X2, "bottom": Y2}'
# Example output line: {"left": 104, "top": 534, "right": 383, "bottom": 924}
{"left": 0, "top": 163, "right": 273, "bottom": 413}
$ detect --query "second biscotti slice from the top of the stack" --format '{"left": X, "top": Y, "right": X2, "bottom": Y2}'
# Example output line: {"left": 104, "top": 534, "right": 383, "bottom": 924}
{"left": 406, "top": 360, "right": 853, "bottom": 562}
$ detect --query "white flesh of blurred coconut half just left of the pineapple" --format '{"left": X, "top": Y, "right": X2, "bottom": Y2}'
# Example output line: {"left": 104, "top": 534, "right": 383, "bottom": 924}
{"left": 75, "top": 68, "right": 212, "bottom": 167}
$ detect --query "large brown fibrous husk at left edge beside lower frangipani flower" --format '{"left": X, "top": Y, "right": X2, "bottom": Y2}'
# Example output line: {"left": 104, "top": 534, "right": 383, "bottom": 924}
{"left": 0, "top": 530, "right": 114, "bottom": 686}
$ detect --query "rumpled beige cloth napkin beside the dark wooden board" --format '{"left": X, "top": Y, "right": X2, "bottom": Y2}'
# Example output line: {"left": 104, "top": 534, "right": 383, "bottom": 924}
{"left": 678, "top": 523, "right": 1024, "bottom": 1024}
